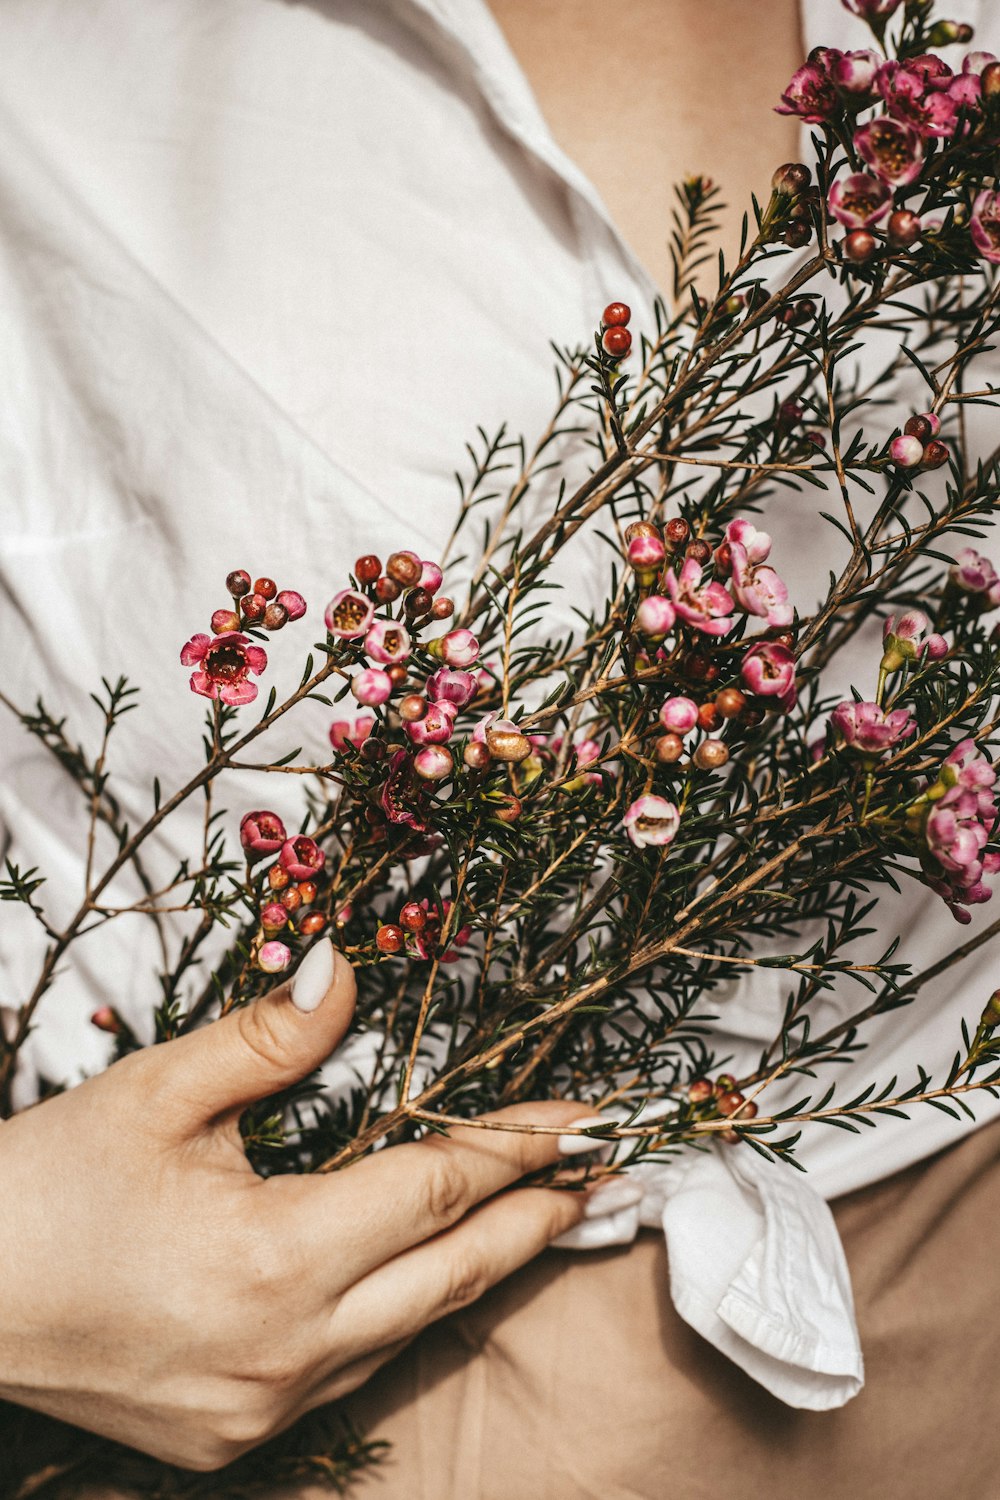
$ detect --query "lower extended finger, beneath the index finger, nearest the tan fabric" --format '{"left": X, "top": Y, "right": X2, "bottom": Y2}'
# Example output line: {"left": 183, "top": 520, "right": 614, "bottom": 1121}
{"left": 331, "top": 1188, "right": 585, "bottom": 1365}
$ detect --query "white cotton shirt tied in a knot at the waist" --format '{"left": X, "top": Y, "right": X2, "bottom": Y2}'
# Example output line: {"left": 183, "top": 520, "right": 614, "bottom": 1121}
{"left": 0, "top": 0, "right": 1000, "bottom": 1407}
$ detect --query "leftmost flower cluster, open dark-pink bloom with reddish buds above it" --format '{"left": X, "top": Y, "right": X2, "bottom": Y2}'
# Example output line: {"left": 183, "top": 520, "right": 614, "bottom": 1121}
{"left": 180, "top": 569, "right": 306, "bottom": 708}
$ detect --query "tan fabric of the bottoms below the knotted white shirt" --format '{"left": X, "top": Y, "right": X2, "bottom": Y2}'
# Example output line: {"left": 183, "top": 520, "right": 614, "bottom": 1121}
{"left": 338, "top": 1124, "right": 1000, "bottom": 1500}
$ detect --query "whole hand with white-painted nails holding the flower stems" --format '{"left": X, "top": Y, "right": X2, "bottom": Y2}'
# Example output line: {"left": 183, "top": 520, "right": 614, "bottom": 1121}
{"left": 0, "top": 939, "right": 583, "bottom": 1470}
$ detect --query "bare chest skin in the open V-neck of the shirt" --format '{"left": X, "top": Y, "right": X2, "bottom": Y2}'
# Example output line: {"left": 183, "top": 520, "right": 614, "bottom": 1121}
{"left": 490, "top": 0, "right": 802, "bottom": 287}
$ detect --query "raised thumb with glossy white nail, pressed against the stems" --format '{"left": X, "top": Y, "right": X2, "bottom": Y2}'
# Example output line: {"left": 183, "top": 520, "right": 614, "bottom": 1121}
{"left": 167, "top": 938, "right": 357, "bottom": 1125}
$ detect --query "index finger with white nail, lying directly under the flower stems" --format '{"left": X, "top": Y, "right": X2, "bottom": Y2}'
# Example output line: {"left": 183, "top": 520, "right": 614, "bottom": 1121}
{"left": 281, "top": 1100, "right": 583, "bottom": 1292}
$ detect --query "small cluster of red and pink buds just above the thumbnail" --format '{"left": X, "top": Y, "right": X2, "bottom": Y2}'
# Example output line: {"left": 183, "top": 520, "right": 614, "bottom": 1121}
{"left": 240, "top": 809, "right": 327, "bottom": 974}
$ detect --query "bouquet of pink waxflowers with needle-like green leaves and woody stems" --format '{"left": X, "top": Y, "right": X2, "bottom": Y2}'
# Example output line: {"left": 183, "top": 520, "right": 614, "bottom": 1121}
{"left": 0, "top": 0, "right": 1000, "bottom": 1482}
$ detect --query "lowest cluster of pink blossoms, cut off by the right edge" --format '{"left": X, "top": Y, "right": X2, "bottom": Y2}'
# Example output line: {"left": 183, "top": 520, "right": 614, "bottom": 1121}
{"left": 906, "top": 740, "right": 1000, "bottom": 923}
